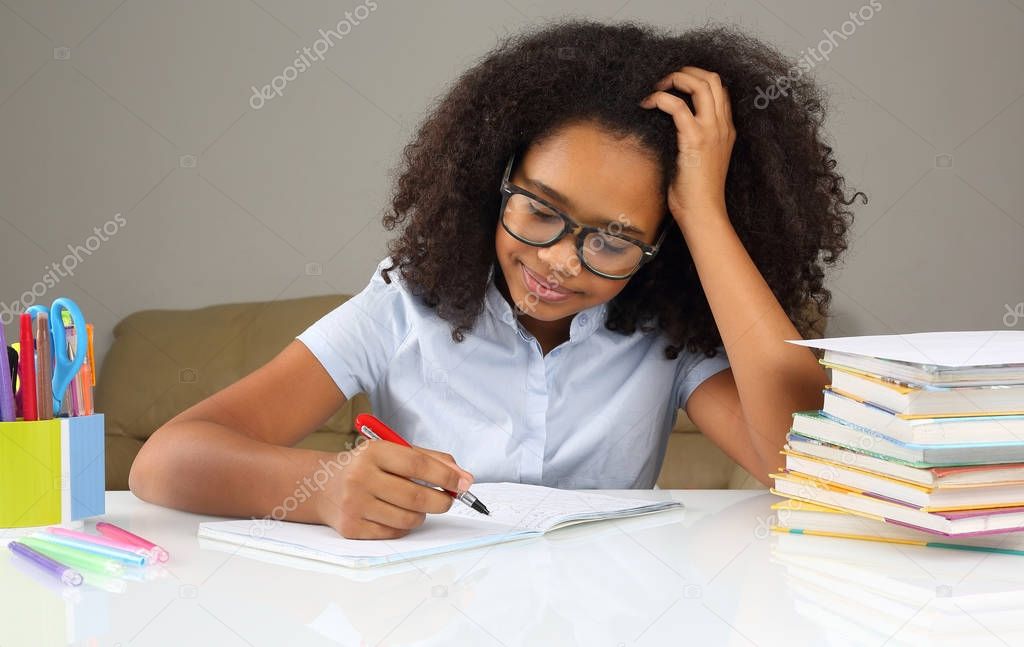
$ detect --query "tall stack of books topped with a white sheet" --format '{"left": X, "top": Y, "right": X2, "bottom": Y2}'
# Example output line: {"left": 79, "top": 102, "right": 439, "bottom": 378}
{"left": 772, "top": 331, "right": 1024, "bottom": 554}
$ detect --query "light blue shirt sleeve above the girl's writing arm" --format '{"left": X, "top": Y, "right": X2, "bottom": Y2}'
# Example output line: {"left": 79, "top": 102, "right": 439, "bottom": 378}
{"left": 296, "top": 258, "right": 415, "bottom": 398}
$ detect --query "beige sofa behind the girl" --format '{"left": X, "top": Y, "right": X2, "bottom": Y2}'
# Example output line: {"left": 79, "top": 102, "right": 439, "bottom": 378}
{"left": 96, "top": 295, "right": 811, "bottom": 489}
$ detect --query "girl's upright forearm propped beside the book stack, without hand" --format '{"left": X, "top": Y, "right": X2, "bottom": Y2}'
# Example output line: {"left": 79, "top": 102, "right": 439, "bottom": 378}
{"left": 681, "top": 211, "right": 826, "bottom": 471}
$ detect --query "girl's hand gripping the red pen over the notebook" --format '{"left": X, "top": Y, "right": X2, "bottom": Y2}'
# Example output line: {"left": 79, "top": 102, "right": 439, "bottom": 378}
{"left": 317, "top": 441, "right": 473, "bottom": 540}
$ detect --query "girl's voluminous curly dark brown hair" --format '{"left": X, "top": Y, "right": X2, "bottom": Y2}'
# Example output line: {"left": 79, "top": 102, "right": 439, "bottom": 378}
{"left": 382, "top": 19, "right": 867, "bottom": 358}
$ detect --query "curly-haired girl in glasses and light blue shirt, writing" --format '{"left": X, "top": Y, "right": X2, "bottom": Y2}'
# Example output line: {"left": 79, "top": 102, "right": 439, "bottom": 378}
{"left": 130, "top": 20, "right": 862, "bottom": 538}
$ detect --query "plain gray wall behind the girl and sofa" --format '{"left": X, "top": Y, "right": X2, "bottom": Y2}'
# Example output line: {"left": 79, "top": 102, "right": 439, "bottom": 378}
{"left": 0, "top": 0, "right": 1024, "bottom": 374}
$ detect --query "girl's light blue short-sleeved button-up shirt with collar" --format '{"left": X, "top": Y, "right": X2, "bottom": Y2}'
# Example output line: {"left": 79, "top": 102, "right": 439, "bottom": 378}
{"left": 298, "top": 258, "right": 729, "bottom": 488}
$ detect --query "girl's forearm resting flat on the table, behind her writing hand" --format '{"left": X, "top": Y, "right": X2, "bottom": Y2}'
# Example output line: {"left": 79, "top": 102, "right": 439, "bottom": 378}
{"left": 129, "top": 420, "right": 340, "bottom": 523}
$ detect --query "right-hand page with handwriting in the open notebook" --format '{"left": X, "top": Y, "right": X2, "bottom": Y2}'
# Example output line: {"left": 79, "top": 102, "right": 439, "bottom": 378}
{"left": 445, "top": 483, "right": 641, "bottom": 530}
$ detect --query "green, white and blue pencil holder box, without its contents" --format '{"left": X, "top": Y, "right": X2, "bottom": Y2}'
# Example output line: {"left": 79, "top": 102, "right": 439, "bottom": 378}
{"left": 0, "top": 414, "right": 104, "bottom": 528}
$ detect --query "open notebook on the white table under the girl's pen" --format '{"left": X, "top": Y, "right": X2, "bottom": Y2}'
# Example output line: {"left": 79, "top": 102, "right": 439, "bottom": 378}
{"left": 199, "top": 483, "right": 682, "bottom": 567}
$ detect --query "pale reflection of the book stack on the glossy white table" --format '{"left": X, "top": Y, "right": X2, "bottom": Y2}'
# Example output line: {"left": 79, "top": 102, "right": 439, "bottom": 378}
{"left": 771, "top": 534, "right": 1024, "bottom": 645}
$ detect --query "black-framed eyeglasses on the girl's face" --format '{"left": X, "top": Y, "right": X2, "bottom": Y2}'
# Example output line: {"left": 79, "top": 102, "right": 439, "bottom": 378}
{"left": 500, "top": 153, "right": 669, "bottom": 281}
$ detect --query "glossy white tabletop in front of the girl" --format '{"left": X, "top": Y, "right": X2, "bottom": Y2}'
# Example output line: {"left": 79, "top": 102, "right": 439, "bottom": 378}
{"left": 0, "top": 490, "right": 1024, "bottom": 647}
